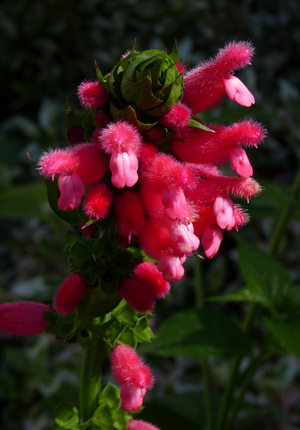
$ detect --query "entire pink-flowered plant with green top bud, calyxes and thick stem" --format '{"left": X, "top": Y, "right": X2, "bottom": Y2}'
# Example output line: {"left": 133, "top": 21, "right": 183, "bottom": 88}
{"left": 0, "top": 42, "right": 265, "bottom": 430}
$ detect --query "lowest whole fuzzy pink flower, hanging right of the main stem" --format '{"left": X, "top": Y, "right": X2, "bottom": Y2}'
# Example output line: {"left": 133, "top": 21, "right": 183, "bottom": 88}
{"left": 111, "top": 345, "right": 154, "bottom": 412}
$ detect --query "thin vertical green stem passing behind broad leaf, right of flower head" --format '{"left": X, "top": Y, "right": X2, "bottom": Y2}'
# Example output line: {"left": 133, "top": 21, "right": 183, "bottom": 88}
{"left": 193, "top": 255, "right": 212, "bottom": 430}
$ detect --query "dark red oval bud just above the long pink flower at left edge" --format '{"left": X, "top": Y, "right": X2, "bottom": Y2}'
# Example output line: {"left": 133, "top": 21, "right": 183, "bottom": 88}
{"left": 53, "top": 273, "right": 87, "bottom": 315}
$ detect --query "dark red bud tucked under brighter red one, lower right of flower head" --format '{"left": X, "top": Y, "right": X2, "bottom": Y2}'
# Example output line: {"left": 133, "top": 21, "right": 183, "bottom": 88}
{"left": 118, "top": 278, "right": 155, "bottom": 313}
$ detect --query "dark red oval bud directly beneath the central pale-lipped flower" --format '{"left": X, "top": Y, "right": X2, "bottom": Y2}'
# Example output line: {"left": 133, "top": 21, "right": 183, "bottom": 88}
{"left": 116, "top": 190, "right": 145, "bottom": 243}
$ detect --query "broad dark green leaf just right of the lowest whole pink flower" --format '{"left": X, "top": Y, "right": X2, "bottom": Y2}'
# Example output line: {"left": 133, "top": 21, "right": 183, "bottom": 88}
{"left": 139, "top": 309, "right": 251, "bottom": 358}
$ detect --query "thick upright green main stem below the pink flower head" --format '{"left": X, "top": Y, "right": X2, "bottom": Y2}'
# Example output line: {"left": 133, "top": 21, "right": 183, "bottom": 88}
{"left": 79, "top": 334, "right": 105, "bottom": 423}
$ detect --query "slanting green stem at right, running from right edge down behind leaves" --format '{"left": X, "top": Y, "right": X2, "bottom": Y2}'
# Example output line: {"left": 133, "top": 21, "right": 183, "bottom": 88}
{"left": 216, "top": 168, "right": 300, "bottom": 430}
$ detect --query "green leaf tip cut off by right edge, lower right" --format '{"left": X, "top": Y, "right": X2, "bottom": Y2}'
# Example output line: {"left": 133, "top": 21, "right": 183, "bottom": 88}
{"left": 264, "top": 317, "right": 300, "bottom": 358}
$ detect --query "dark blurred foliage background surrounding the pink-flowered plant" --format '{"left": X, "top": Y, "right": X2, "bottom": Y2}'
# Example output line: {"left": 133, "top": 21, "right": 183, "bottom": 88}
{"left": 0, "top": 0, "right": 300, "bottom": 430}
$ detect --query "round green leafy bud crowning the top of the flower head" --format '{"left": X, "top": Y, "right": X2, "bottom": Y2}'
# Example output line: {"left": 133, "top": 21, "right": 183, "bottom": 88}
{"left": 102, "top": 44, "right": 183, "bottom": 131}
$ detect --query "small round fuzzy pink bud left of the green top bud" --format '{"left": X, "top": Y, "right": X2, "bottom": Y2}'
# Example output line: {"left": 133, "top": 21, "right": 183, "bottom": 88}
{"left": 78, "top": 81, "right": 109, "bottom": 109}
